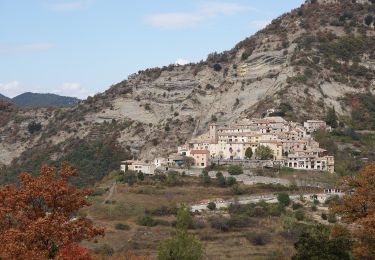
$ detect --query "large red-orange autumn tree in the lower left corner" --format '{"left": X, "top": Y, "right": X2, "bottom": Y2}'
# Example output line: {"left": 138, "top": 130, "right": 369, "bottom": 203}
{"left": 0, "top": 163, "right": 103, "bottom": 259}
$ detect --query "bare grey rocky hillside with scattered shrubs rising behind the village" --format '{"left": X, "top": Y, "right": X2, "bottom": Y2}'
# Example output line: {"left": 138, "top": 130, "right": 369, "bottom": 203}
{"left": 0, "top": 0, "right": 375, "bottom": 187}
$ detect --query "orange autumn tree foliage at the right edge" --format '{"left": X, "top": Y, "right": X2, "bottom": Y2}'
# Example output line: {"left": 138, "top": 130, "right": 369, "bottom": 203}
{"left": 333, "top": 164, "right": 375, "bottom": 259}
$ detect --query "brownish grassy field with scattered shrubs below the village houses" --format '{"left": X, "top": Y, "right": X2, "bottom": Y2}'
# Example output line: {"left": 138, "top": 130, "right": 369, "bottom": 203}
{"left": 80, "top": 173, "right": 332, "bottom": 259}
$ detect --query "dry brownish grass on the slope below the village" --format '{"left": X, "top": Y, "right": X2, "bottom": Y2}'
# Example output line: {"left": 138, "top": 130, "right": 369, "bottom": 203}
{"left": 83, "top": 177, "right": 302, "bottom": 259}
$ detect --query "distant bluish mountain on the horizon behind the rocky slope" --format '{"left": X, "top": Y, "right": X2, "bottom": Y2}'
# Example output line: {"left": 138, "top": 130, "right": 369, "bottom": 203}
{"left": 11, "top": 92, "right": 80, "bottom": 107}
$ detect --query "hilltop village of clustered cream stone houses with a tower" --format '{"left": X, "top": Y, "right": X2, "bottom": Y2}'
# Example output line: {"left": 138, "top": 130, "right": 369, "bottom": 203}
{"left": 121, "top": 117, "right": 334, "bottom": 174}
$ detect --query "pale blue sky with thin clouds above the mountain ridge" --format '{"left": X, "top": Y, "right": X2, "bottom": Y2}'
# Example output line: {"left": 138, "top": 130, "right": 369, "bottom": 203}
{"left": 0, "top": 0, "right": 304, "bottom": 98}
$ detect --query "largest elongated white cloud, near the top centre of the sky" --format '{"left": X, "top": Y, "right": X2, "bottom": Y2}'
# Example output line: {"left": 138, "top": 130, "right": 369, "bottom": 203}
{"left": 144, "top": 3, "right": 255, "bottom": 30}
